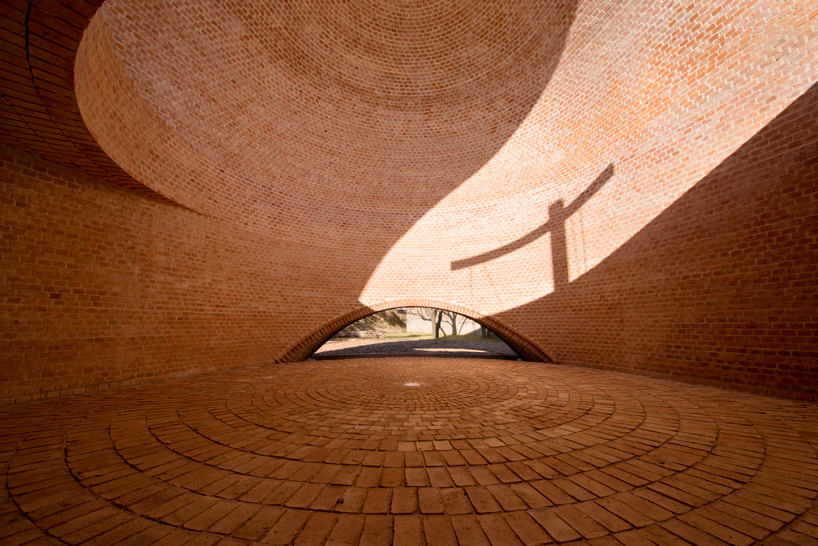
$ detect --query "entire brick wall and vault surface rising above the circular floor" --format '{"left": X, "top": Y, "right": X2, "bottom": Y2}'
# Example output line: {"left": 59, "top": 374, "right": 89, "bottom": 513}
{"left": 0, "top": 0, "right": 818, "bottom": 402}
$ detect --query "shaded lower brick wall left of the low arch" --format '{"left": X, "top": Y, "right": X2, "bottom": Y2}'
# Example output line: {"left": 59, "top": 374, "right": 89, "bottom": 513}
{"left": 0, "top": 148, "right": 365, "bottom": 402}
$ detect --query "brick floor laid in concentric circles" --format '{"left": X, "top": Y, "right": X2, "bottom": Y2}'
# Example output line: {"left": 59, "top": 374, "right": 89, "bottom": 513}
{"left": 0, "top": 357, "right": 818, "bottom": 546}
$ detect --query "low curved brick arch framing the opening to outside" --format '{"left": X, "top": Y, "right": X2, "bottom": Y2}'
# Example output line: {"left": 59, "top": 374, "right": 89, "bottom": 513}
{"left": 276, "top": 298, "right": 553, "bottom": 362}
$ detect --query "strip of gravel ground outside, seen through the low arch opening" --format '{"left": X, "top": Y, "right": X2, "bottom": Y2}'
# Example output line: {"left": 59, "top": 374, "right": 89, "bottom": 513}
{"left": 315, "top": 338, "right": 517, "bottom": 357}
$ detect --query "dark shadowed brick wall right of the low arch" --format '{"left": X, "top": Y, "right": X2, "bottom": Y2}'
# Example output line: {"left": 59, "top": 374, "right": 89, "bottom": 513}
{"left": 495, "top": 85, "right": 818, "bottom": 400}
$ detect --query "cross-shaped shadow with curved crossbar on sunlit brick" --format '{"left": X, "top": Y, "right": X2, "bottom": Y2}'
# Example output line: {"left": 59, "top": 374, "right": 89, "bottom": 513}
{"left": 451, "top": 163, "right": 614, "bottom": 289}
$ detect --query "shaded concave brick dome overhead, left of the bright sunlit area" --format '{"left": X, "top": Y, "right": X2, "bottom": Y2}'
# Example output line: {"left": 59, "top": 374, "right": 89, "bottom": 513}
{"left": 77, "top": 0, "right": 574, "bottom": 239}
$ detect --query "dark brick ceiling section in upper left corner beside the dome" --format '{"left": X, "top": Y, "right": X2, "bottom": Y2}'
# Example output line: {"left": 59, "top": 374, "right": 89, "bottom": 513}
{"left": 0, "top": 0, "right": 174, "bottom": 202}
